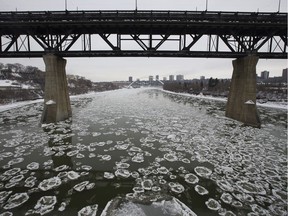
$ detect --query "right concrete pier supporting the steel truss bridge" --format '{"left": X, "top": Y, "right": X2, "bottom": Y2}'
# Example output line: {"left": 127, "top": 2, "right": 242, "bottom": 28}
{"left": 225, "top": 55, "right": 261, "bottom": 127}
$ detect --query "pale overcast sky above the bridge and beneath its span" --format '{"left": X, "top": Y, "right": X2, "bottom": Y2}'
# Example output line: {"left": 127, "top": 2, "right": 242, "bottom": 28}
{"left": 0, "top": 0, "right": 287, "bottom": 82}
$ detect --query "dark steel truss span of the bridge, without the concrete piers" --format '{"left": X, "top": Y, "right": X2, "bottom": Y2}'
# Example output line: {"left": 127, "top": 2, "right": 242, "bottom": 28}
{"left": 0, "top": 10, "right": 287, "bottom": 59}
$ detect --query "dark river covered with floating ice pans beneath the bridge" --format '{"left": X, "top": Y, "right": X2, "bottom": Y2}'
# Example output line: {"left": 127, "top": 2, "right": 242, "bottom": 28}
{"left": 0, "top": 89, "right": 287, "bottom": 216}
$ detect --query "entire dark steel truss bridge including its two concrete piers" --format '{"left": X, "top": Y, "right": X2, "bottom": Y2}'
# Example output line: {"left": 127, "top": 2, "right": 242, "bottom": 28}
{"left": 0, "top": 10, "right": 287, "bottom": 127}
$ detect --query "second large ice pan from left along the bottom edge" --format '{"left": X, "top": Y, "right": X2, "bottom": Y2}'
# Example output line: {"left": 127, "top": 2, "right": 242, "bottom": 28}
{"left": 34, "top": 196, "right": 57, "bottom": 215}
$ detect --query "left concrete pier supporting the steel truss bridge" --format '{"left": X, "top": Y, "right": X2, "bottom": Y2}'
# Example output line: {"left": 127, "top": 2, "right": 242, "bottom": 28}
{"left": 41, "top": 54, "right": 72, "bottom": 123}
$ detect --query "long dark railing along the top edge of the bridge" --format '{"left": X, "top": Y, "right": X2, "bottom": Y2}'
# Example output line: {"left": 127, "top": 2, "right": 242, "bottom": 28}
{"left": 0, "top": 10, "right": 287, "bottom": 23}
